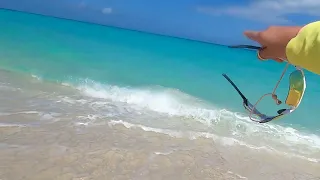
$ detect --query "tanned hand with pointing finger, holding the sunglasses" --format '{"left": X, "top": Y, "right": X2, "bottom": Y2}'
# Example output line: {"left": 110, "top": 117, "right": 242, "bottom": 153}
{"left": 244, "top": 26, "right": 302, "bottom": 62}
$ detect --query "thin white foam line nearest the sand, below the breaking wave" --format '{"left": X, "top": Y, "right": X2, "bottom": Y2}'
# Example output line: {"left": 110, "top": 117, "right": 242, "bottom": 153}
{"left": 108, "top": 120, "right": 319, "bottom": 163}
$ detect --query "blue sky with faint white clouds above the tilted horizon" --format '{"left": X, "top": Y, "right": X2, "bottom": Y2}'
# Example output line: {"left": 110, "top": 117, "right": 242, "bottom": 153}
{"left": 0, "top": 0, "right": 320, "bottom": 44}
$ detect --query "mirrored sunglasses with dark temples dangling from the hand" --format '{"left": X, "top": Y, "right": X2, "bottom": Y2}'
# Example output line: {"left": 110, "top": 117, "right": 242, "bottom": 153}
{"left": 222, "top": 45, "right": 306, "bottom": 123}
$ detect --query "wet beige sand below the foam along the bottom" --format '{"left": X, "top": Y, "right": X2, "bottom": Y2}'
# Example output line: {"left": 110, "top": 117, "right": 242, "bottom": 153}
{"left": 0, "top": 117, "right": 320, "bottom": 180}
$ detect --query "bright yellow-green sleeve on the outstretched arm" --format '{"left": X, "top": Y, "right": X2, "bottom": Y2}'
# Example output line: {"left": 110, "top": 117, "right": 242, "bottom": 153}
{"left": 286, "top": 21, "right": 320, "bottom": 75}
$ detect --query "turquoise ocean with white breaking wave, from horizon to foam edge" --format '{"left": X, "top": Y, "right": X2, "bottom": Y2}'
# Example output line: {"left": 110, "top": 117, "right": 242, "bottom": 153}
{"left": 0, "top": 10, "right": 320, "bottom": 164}
